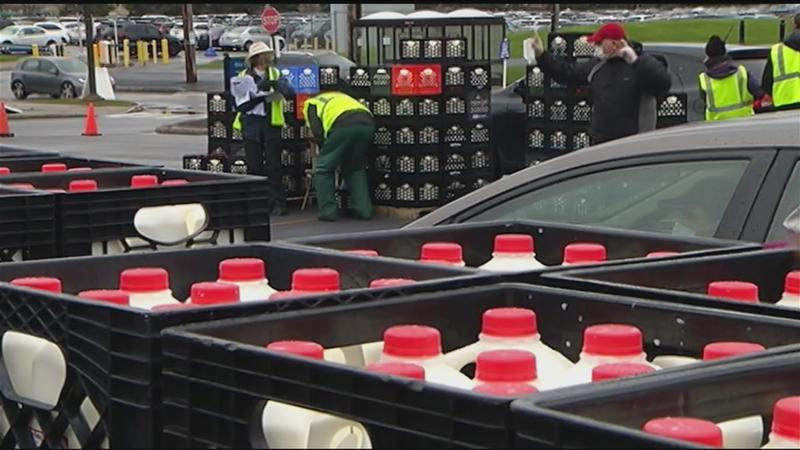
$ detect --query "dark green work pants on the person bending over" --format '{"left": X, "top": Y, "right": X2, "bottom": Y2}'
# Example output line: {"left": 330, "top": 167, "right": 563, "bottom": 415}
{"left": 314, "top": 125, "right": 375, "bottom": 219}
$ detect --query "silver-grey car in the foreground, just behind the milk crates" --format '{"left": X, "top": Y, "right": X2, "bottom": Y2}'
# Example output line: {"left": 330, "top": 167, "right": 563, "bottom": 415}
{"left": 408, "top": 111, "right": 800, "bottom": 242}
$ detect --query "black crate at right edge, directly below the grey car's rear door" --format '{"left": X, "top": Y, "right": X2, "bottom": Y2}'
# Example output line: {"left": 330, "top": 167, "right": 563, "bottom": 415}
{"left": 545, "top": 248, "right": 800, "bottom": 319}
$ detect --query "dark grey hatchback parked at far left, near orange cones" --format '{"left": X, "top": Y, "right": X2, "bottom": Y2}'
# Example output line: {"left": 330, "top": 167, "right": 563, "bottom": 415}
{"left": 11, "top": 57, "right": 116, "bottom": 100}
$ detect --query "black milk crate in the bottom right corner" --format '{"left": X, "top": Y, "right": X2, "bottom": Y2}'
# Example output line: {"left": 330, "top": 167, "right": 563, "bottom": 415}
{"left": 511, "top": 354, "right": 800, "bottom": 448}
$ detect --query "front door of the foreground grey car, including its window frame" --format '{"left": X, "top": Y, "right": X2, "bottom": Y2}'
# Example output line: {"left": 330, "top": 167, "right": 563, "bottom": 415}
{"left": 448, "top": 149, "right": 776, "bottom": 239}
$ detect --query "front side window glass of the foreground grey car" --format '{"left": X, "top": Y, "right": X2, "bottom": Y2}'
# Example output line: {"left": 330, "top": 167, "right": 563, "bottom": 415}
{"left": 469, "top": 160, "right": 748, "bottom": 237}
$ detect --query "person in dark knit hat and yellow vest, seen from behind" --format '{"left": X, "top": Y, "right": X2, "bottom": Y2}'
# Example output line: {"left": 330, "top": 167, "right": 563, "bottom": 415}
{"left": 699, "top": 35, "right": 764, "bottom": 120}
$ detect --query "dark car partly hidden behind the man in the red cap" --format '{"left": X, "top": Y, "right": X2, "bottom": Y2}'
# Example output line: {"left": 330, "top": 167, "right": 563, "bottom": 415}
{"left": 492, "top": 44, "right": 769, "bottom": 173}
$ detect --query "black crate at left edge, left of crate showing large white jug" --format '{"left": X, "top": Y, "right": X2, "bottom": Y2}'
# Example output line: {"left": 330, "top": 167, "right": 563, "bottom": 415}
{"left": 0, "top": 187, "right": 56, "bottom": 263}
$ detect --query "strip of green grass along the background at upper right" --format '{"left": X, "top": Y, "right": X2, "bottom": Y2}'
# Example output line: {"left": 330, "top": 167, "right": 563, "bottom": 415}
{"left": 508, "top": 19, "right": 792, "bottom": 58}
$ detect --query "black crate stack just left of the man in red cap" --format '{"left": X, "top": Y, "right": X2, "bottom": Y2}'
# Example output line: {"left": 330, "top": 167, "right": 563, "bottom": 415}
{"left": 525, "top": 33, "right": 594, "bottom": 165}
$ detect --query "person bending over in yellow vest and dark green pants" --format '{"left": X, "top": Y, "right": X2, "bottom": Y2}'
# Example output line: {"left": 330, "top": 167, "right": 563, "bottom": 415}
{"left": 303, "top": 92, "right": 375, "bottom": 222}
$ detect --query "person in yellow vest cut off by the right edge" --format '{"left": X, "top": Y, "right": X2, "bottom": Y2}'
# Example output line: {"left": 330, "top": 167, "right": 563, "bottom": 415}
{"left": 761, "top": 13, "right": 800, "bottom": 109}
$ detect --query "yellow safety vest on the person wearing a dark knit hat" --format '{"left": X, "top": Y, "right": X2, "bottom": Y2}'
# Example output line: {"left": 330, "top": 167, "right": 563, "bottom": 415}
{"left": 700, "top": 66, "right": 753, "bottom": 120}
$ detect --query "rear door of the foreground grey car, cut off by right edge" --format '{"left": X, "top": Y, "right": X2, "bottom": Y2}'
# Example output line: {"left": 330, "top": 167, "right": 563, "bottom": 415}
{"left": 741, "top": 148, "right": 800, "bottom": 242}
